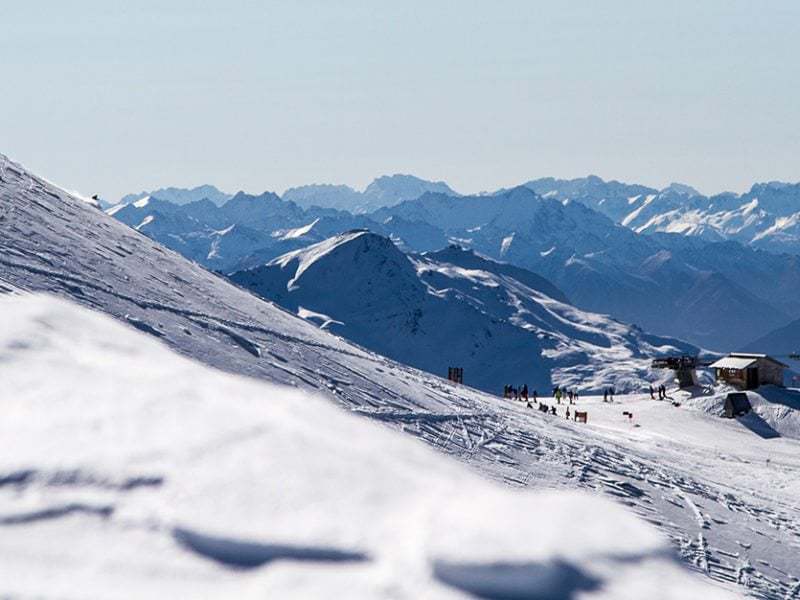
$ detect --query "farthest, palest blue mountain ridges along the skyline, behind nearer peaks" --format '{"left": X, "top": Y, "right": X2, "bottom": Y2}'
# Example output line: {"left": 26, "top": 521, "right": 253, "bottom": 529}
{"left": 116, "top": 174, "right": 800, "bottom": 253}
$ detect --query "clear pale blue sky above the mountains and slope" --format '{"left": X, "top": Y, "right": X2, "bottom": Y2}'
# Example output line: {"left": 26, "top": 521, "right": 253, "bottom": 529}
{"left": 0, "top": 0, "right": 800, "bottom": 199}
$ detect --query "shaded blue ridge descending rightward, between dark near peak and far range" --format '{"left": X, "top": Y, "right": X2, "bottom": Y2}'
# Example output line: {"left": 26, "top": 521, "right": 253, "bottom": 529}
{"left": 371, "top": 187, "right": 800, "bottom": 350}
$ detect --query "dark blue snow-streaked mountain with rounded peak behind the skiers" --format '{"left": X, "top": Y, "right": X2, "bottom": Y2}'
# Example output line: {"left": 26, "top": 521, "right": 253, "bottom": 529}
{"left": 231, "top": 230, "right": 697, "bottom": 394}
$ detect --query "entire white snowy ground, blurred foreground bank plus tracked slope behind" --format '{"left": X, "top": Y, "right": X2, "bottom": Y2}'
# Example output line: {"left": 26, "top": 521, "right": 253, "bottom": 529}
{"left": 0, "top": 154, "right": 800, "bottom": 599}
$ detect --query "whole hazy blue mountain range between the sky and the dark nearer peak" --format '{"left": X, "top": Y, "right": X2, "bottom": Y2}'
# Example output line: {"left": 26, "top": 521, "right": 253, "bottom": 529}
{"left": 107, "top": 176, "right": 800, "bottom": 350}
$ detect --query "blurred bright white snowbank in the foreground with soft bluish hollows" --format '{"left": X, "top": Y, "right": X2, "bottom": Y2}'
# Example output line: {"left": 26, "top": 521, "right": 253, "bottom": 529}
{"left": 0, "top": 295, "right": 727, "bottom": 599}
